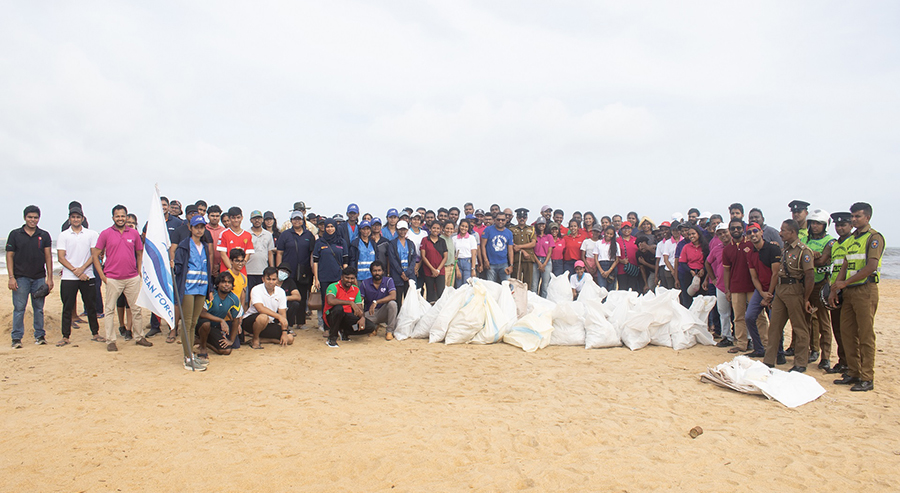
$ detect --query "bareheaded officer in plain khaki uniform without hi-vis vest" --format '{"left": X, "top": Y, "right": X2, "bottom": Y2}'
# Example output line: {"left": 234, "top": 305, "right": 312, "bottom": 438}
{"left": 763, "top": 219, "right": 815, "bottom": 372}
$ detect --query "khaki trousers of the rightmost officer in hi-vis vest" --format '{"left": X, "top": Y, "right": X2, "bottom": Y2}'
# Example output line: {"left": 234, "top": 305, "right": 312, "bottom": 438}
{"left": 841, "top": 282, "right": 878, "bottom": 381}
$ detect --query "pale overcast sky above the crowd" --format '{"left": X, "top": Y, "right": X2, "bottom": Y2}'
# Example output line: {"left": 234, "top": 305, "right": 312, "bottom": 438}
{"left": 0, "top": 0, "right": 900, "bottom": 241}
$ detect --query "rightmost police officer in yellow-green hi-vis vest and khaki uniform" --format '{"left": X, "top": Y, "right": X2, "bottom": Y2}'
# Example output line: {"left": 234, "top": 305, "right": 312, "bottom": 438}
{"left": 828, "top": 202, "right": 884, "bottom": 392}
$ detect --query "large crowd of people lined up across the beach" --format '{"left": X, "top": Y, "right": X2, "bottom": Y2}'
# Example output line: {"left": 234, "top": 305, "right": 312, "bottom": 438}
{"left": 6, "top": 197, "right": 884, "bottom": 391}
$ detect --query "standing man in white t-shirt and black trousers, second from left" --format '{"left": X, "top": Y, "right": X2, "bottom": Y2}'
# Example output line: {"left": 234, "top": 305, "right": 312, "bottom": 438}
{"left": 56, "top": 207, "right": 106, "bottom": 346}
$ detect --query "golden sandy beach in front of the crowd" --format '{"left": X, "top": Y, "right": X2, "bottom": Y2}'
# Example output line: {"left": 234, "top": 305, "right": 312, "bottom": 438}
{"left": 0, "top": 279, "right": 900, "bottom": 492}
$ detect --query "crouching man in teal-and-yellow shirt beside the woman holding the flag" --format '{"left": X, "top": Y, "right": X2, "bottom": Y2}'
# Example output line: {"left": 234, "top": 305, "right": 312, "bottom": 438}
{"left": 197, "top": 271, "right": 244, "bottom": 360}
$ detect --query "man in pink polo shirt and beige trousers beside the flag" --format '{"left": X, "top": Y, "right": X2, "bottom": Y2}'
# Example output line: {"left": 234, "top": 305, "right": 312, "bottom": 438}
{"left": 91, "top": 205, "right": 153, "bottom": 351}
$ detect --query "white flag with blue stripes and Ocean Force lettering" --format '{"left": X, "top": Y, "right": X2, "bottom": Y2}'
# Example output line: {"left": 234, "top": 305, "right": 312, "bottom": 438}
{"left": 137, "top": 184, "right": 175, "bottom": 327}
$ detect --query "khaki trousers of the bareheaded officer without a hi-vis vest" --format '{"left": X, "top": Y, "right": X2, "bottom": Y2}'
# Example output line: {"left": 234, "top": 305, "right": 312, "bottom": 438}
{"left": 763, "top": 283, "right": 809, "bottom": 368}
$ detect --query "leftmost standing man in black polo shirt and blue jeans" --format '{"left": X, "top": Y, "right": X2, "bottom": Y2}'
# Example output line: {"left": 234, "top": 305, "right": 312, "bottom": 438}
{"left": 6, "top": 205, "right": 53, "bottom": 349}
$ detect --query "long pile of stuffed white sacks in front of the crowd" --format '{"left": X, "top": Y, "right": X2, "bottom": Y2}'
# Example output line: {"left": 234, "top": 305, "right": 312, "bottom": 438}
{"left": 394, "top": 273, "right": 716, "bottom": 352}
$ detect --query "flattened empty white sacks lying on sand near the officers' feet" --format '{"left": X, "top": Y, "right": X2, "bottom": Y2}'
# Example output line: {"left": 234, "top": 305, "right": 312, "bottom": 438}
{"left": 700, "top": 356, "right": 825, "bottom": 407}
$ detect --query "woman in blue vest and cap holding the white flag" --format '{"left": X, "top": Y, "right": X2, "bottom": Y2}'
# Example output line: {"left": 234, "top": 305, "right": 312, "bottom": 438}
{"left": 172, "top": 215, "right": 210, "bottom": 343}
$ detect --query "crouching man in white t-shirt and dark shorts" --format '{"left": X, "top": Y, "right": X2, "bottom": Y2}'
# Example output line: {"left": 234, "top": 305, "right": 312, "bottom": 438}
{"left": 241, "top": 267, "right": 294, "bottom": 349}
